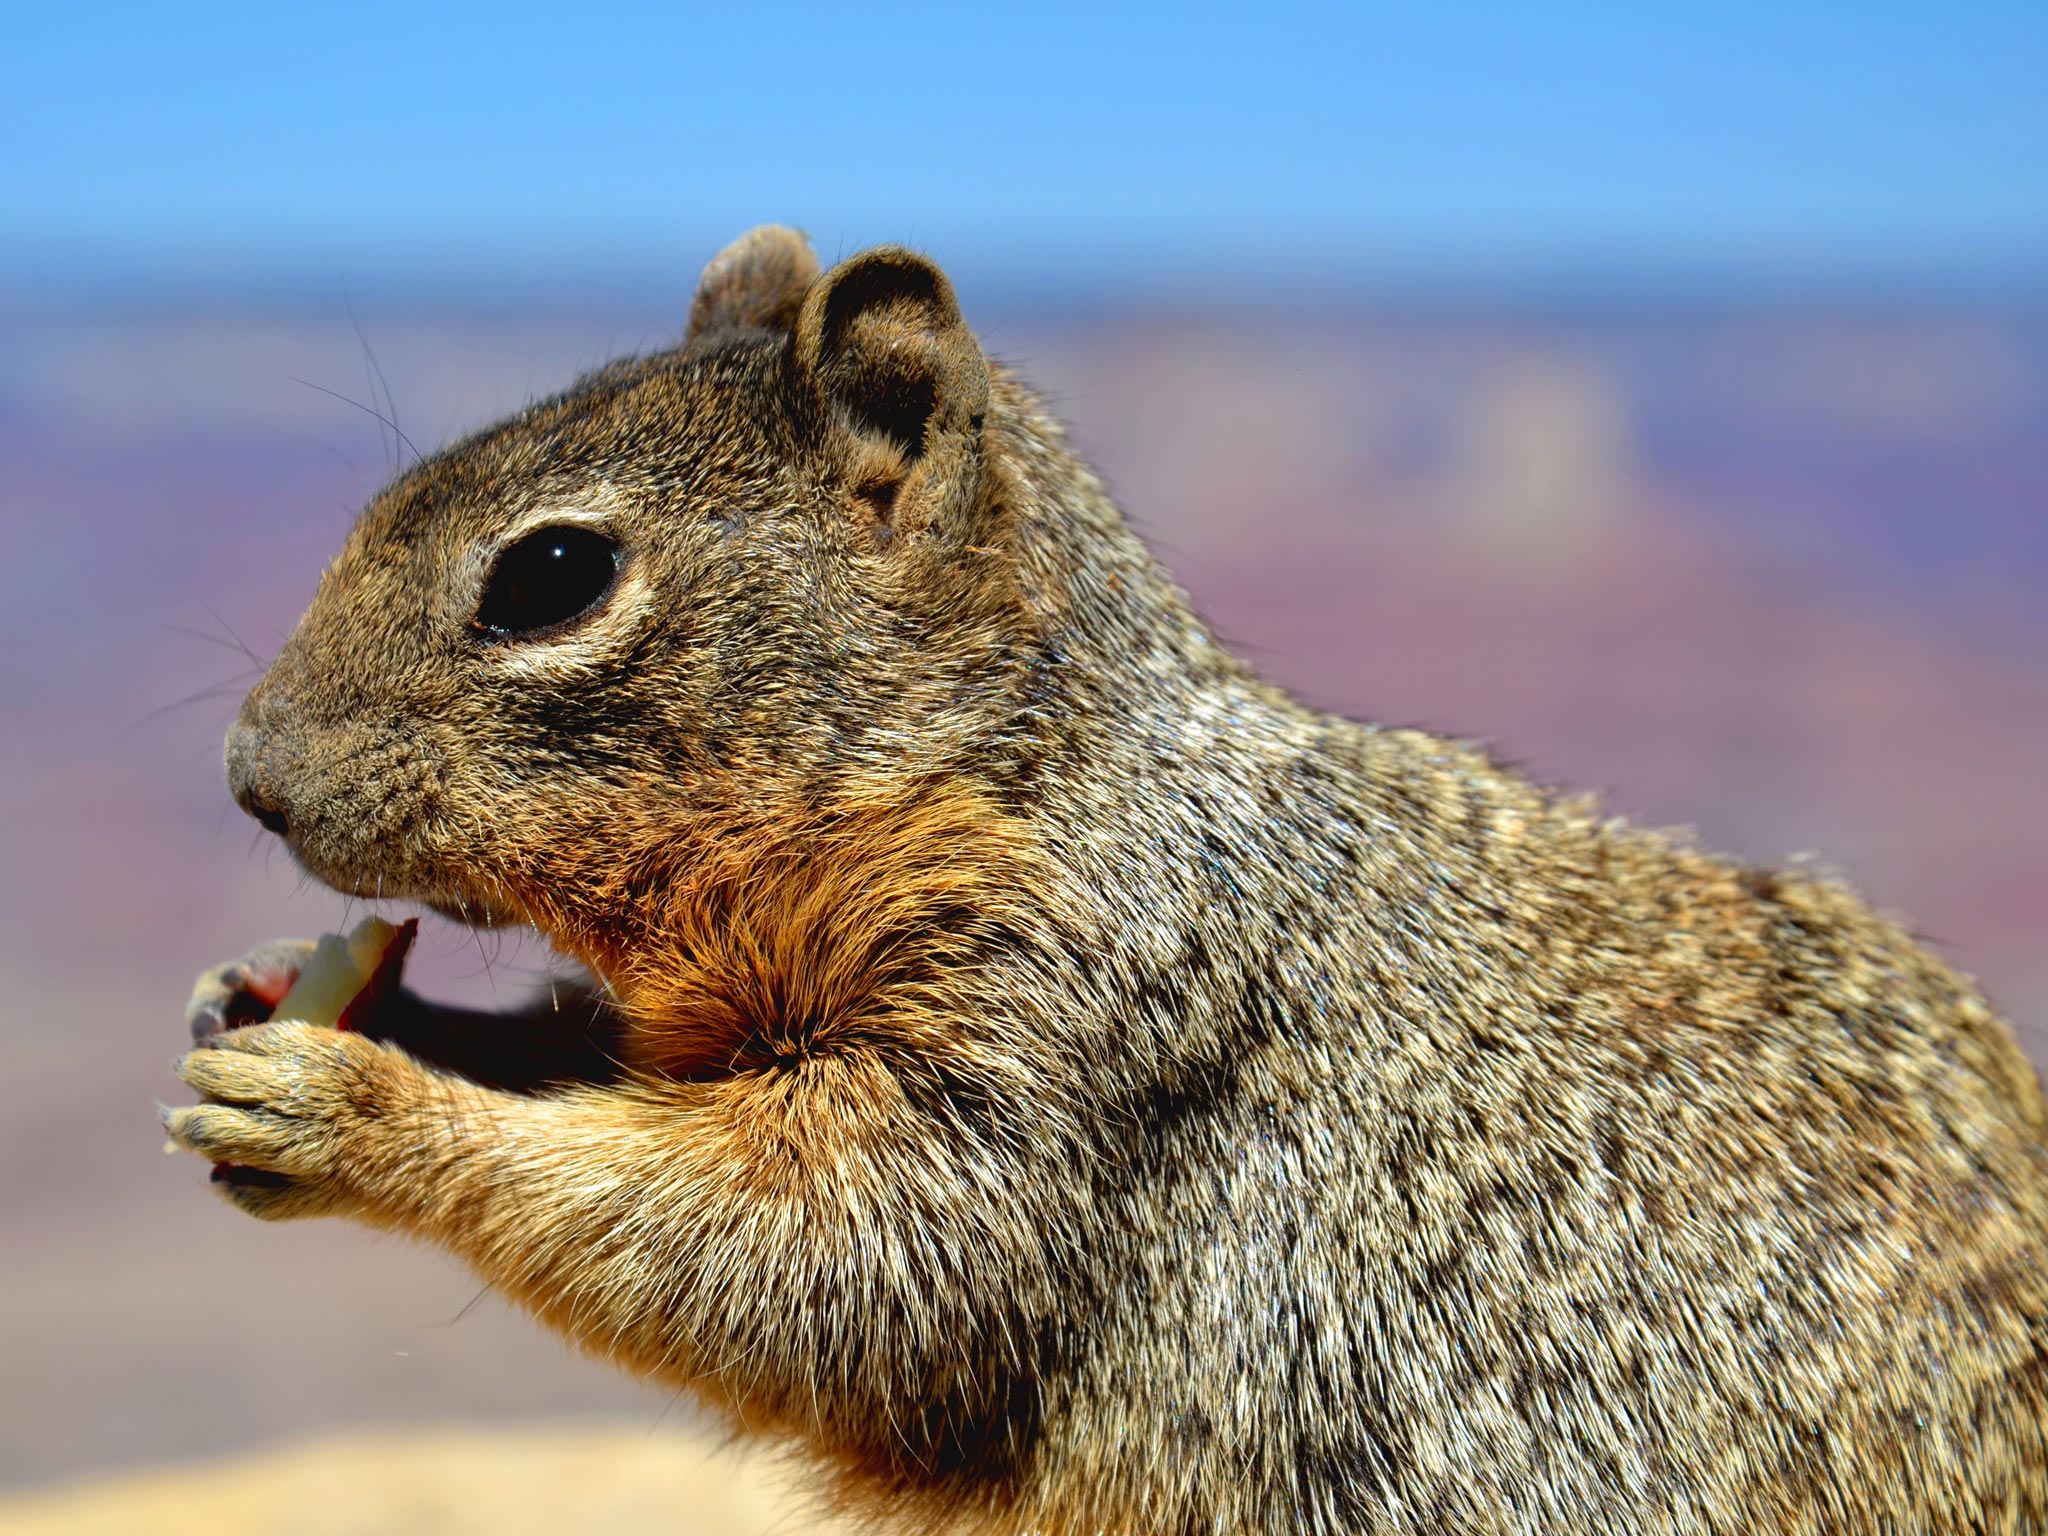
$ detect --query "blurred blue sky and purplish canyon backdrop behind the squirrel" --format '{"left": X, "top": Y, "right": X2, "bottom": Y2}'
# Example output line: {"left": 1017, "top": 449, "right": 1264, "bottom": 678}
{"left": 0, "top": 4, "right": 2048, "bottom": 1515}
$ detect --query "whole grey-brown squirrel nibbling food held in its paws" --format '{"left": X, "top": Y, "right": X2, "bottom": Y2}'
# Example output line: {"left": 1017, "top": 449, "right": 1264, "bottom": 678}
{"left": 164, "top": 227, "right": 2048, "bottom": 1536}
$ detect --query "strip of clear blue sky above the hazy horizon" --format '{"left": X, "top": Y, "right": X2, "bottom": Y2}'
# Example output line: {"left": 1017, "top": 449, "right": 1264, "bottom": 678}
{"left": 0, "top": 0, "right": 2048, "bottom": 290}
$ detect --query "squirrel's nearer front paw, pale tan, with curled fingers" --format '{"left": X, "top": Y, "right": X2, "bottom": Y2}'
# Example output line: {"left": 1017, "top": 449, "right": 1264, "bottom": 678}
{"left": 164, "top": 1022, "right": 422, "bottom": 1221}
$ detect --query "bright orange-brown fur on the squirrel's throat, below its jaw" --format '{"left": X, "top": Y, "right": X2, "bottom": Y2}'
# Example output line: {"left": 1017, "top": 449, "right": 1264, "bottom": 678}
{"left": 500, "top": 780, "right": 1044, "bottom": 1077}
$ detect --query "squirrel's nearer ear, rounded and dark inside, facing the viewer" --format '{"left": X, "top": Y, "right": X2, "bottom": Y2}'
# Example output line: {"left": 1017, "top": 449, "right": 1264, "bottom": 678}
{"left": 793, "top": 246, "right": 989, "bottom": 461}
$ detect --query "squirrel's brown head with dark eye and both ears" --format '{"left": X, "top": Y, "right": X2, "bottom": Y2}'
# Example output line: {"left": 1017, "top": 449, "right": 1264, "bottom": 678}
{"left": 227, "top": 227, "right": 1036, "bottom": 920}
